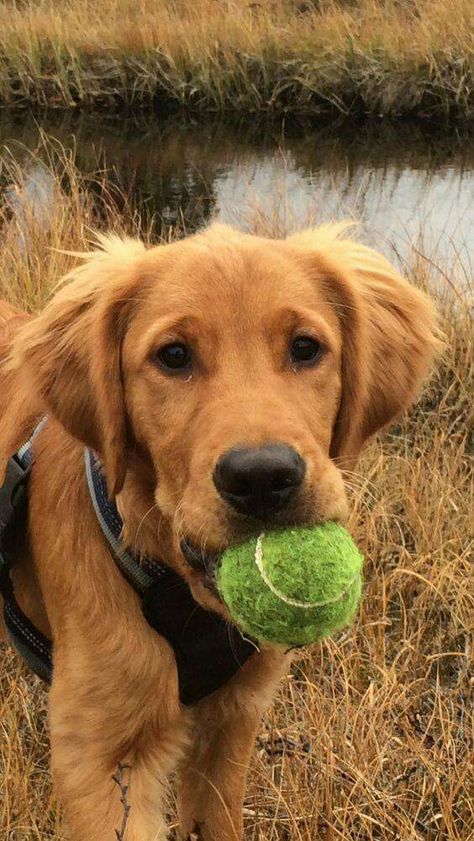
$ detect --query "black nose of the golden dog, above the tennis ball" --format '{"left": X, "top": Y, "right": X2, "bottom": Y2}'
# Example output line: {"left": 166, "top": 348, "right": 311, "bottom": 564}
{"left": 213, "top": 444, "right": 306, "bottom": 520}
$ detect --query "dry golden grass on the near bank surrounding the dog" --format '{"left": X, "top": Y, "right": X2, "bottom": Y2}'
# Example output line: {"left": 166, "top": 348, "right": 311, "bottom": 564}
{"left": 0, "top": 148, "right": 474, "bottom": 841}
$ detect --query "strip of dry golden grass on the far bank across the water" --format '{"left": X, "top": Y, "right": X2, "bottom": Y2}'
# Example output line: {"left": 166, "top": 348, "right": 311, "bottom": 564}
{"left": 0, "top": 0, "right": 474, "bottom": 119}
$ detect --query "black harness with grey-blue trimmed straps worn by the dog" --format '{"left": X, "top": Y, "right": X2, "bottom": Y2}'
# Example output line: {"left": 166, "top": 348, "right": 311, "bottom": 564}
{"left": 0, "top": 422, "right": 256, "bottom": 705}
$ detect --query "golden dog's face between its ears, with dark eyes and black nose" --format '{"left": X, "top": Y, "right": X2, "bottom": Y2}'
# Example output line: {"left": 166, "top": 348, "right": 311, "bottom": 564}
{"left": 122, "top": 233, "right": 347, "bottom": 554}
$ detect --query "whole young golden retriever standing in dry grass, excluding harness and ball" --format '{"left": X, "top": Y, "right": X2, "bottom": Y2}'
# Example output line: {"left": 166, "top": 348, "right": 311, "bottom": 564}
{"left": 0, "top": 224, "right": 436, "bottom": 841}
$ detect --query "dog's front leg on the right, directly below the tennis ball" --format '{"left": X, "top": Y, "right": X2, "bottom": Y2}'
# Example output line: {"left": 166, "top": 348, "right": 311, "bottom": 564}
{"left": 179, "top": 651, "right": 290, "bottom": 841}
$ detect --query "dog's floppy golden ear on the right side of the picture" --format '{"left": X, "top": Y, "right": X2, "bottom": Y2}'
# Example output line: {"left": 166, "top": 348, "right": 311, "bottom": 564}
{"left": 289, "top": 223, "right": 438, "bottom": 463}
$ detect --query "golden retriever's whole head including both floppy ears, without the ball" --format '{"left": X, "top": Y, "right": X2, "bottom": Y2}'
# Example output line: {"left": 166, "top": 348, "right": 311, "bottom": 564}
{"left": 3, "top": 225, "right": 435, "bottom": 596}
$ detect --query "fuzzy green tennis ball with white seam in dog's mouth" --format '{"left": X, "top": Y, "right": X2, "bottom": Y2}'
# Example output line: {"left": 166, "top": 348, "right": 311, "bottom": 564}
{"left": 217, "top": 523, "right": 363, "bottom": 646}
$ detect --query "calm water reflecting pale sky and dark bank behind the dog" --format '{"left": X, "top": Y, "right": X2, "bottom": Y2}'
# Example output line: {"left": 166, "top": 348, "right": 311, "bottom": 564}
{"left": 0, "top": 113, "right": 474, "bottom": 266}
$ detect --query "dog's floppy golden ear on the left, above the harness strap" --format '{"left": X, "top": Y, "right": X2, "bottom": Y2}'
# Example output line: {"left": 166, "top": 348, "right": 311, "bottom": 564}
{"left": 6, "top": 237, "right": 144, "bottom": 494}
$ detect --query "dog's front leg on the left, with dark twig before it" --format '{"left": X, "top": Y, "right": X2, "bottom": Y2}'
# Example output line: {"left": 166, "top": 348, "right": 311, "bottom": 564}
{"left": 50, "top": 636, "right": 185, "bottom": 841}
